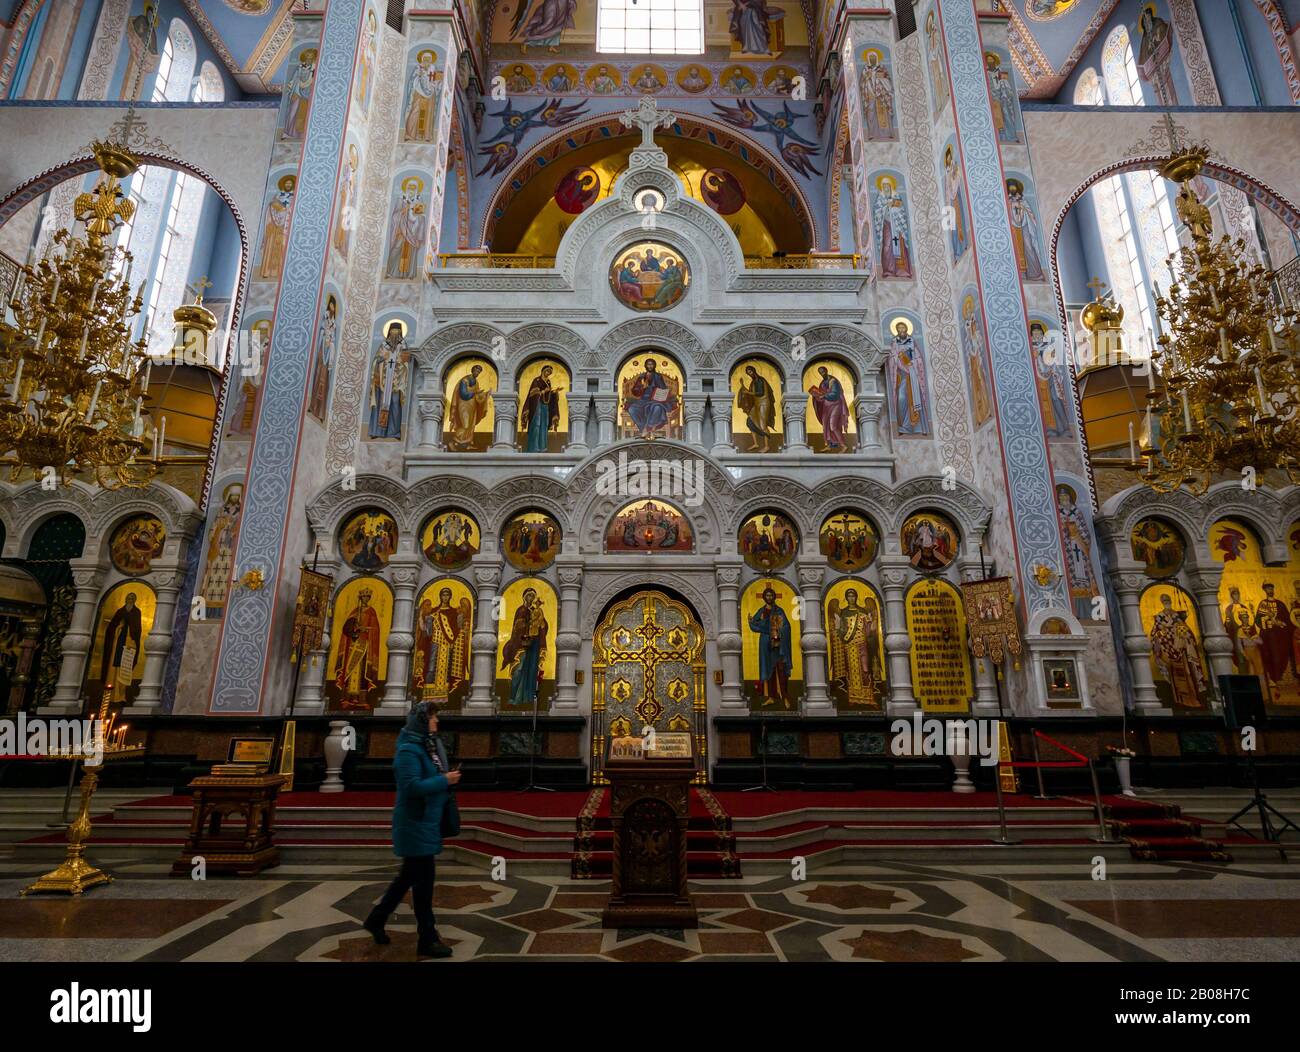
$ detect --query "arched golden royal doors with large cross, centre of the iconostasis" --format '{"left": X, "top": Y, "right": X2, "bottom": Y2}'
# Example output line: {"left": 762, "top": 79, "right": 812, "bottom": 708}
{"left": 592, "top": 592, "right": 709, "bottom": 784}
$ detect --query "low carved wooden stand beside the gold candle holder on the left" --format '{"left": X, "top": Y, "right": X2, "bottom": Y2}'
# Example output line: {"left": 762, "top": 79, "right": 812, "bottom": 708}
{"left": 172, "top": 775, "right": 289, "bottom": 876}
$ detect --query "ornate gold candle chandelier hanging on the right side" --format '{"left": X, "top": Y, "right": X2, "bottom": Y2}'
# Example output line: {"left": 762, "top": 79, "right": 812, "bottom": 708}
{"left": 1128, "top": 147, "right": 1300, "bottom": 494}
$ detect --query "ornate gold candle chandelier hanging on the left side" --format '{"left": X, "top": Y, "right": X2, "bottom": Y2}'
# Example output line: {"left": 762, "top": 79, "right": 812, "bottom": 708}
{"left": 0, "top": 142, "right": 161, "bottom": 489}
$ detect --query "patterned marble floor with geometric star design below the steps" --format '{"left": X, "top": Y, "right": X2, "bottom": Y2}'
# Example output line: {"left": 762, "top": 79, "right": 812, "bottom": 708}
{"left": 0, "top": 858, "right": 1300, "bottom": 964}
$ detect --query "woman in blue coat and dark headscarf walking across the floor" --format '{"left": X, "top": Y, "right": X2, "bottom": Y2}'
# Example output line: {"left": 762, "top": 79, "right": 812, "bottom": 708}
{"left": 364, "top": 701, "right": 460, "bottom": 957}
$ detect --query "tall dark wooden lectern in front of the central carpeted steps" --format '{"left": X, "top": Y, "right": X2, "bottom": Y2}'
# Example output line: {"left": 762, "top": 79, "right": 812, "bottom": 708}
{"left": 601, "top": 743, "right": 699, "bottom": 928}
